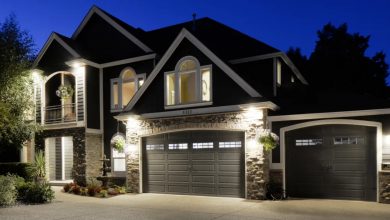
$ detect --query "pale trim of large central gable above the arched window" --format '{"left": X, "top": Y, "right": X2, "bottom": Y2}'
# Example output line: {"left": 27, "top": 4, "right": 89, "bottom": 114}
{"left": 124, "top": 28, "right": 261, "bottom": 111}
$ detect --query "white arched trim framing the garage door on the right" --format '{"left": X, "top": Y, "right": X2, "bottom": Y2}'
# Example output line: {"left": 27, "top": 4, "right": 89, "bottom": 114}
{"left": 271, "top": 119, "right": 383, "bottom": 201}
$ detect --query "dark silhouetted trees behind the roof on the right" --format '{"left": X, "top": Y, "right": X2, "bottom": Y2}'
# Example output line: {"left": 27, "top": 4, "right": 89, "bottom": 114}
{"left": 287, "top": 23, "right": 389, "bottom": 97}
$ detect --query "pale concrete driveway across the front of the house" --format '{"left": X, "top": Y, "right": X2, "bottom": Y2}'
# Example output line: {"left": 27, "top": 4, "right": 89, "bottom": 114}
{"left": 0, "top": 187, "right": 390, "bottom": 220}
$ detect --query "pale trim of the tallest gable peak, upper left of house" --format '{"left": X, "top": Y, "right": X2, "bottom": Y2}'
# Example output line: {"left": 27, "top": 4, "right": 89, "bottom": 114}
{"left": 72, "top": 5, "right": 153, "bottom": 53}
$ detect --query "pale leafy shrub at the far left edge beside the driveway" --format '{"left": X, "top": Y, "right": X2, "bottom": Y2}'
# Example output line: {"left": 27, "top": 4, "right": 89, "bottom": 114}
{"left": 0, "top": 175, "right": 17, "bottom": 206}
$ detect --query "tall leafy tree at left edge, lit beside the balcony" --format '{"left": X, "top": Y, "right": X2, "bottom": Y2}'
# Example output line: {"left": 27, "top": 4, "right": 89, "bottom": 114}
{"left": 0, "top": 15, "right": 36, "bottom": 154}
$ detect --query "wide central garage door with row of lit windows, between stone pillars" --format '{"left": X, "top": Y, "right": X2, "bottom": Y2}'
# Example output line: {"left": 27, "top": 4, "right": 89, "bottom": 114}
{"left": 142, "top": 131, "right": 244, "bottom": 197}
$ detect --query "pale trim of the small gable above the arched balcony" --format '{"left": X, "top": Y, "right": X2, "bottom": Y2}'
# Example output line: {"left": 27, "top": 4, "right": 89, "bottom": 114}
{"left": 33, "top": 32, "right": 81, "bottom": 68}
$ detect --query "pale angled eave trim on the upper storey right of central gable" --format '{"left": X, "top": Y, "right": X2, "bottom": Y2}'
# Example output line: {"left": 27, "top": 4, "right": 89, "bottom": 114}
{"left": 229, "top": 52, "right": 308, "bottom": 85}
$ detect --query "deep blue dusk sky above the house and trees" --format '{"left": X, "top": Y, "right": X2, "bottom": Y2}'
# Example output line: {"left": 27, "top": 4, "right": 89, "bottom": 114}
{"left": 0, "top": 0, "right": 390, "bottom": 69}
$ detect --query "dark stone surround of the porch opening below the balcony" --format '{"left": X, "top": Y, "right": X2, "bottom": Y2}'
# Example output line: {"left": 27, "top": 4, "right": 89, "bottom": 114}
{"left": 35, "top": 128, "right": 86, "bottom": 185}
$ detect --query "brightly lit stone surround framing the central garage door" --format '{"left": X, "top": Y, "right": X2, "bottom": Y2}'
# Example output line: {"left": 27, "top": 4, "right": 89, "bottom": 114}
{"left": 126, "top": 110, "right": 268, "bottom": 199}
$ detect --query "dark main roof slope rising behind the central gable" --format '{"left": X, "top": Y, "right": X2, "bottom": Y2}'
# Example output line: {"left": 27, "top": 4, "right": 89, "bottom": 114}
{"left": 144, "top": 17, "right": 280, "bottom": 61}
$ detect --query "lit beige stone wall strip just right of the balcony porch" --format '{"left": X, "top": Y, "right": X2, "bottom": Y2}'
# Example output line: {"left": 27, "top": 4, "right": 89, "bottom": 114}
{"left": 85, "top": 133, "right": 103, "bottom": 180}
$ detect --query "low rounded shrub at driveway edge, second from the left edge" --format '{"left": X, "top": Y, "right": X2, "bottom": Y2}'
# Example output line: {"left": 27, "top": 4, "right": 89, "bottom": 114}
{"left": 23, "top": 182, "right": 54, "bottom": 203}
